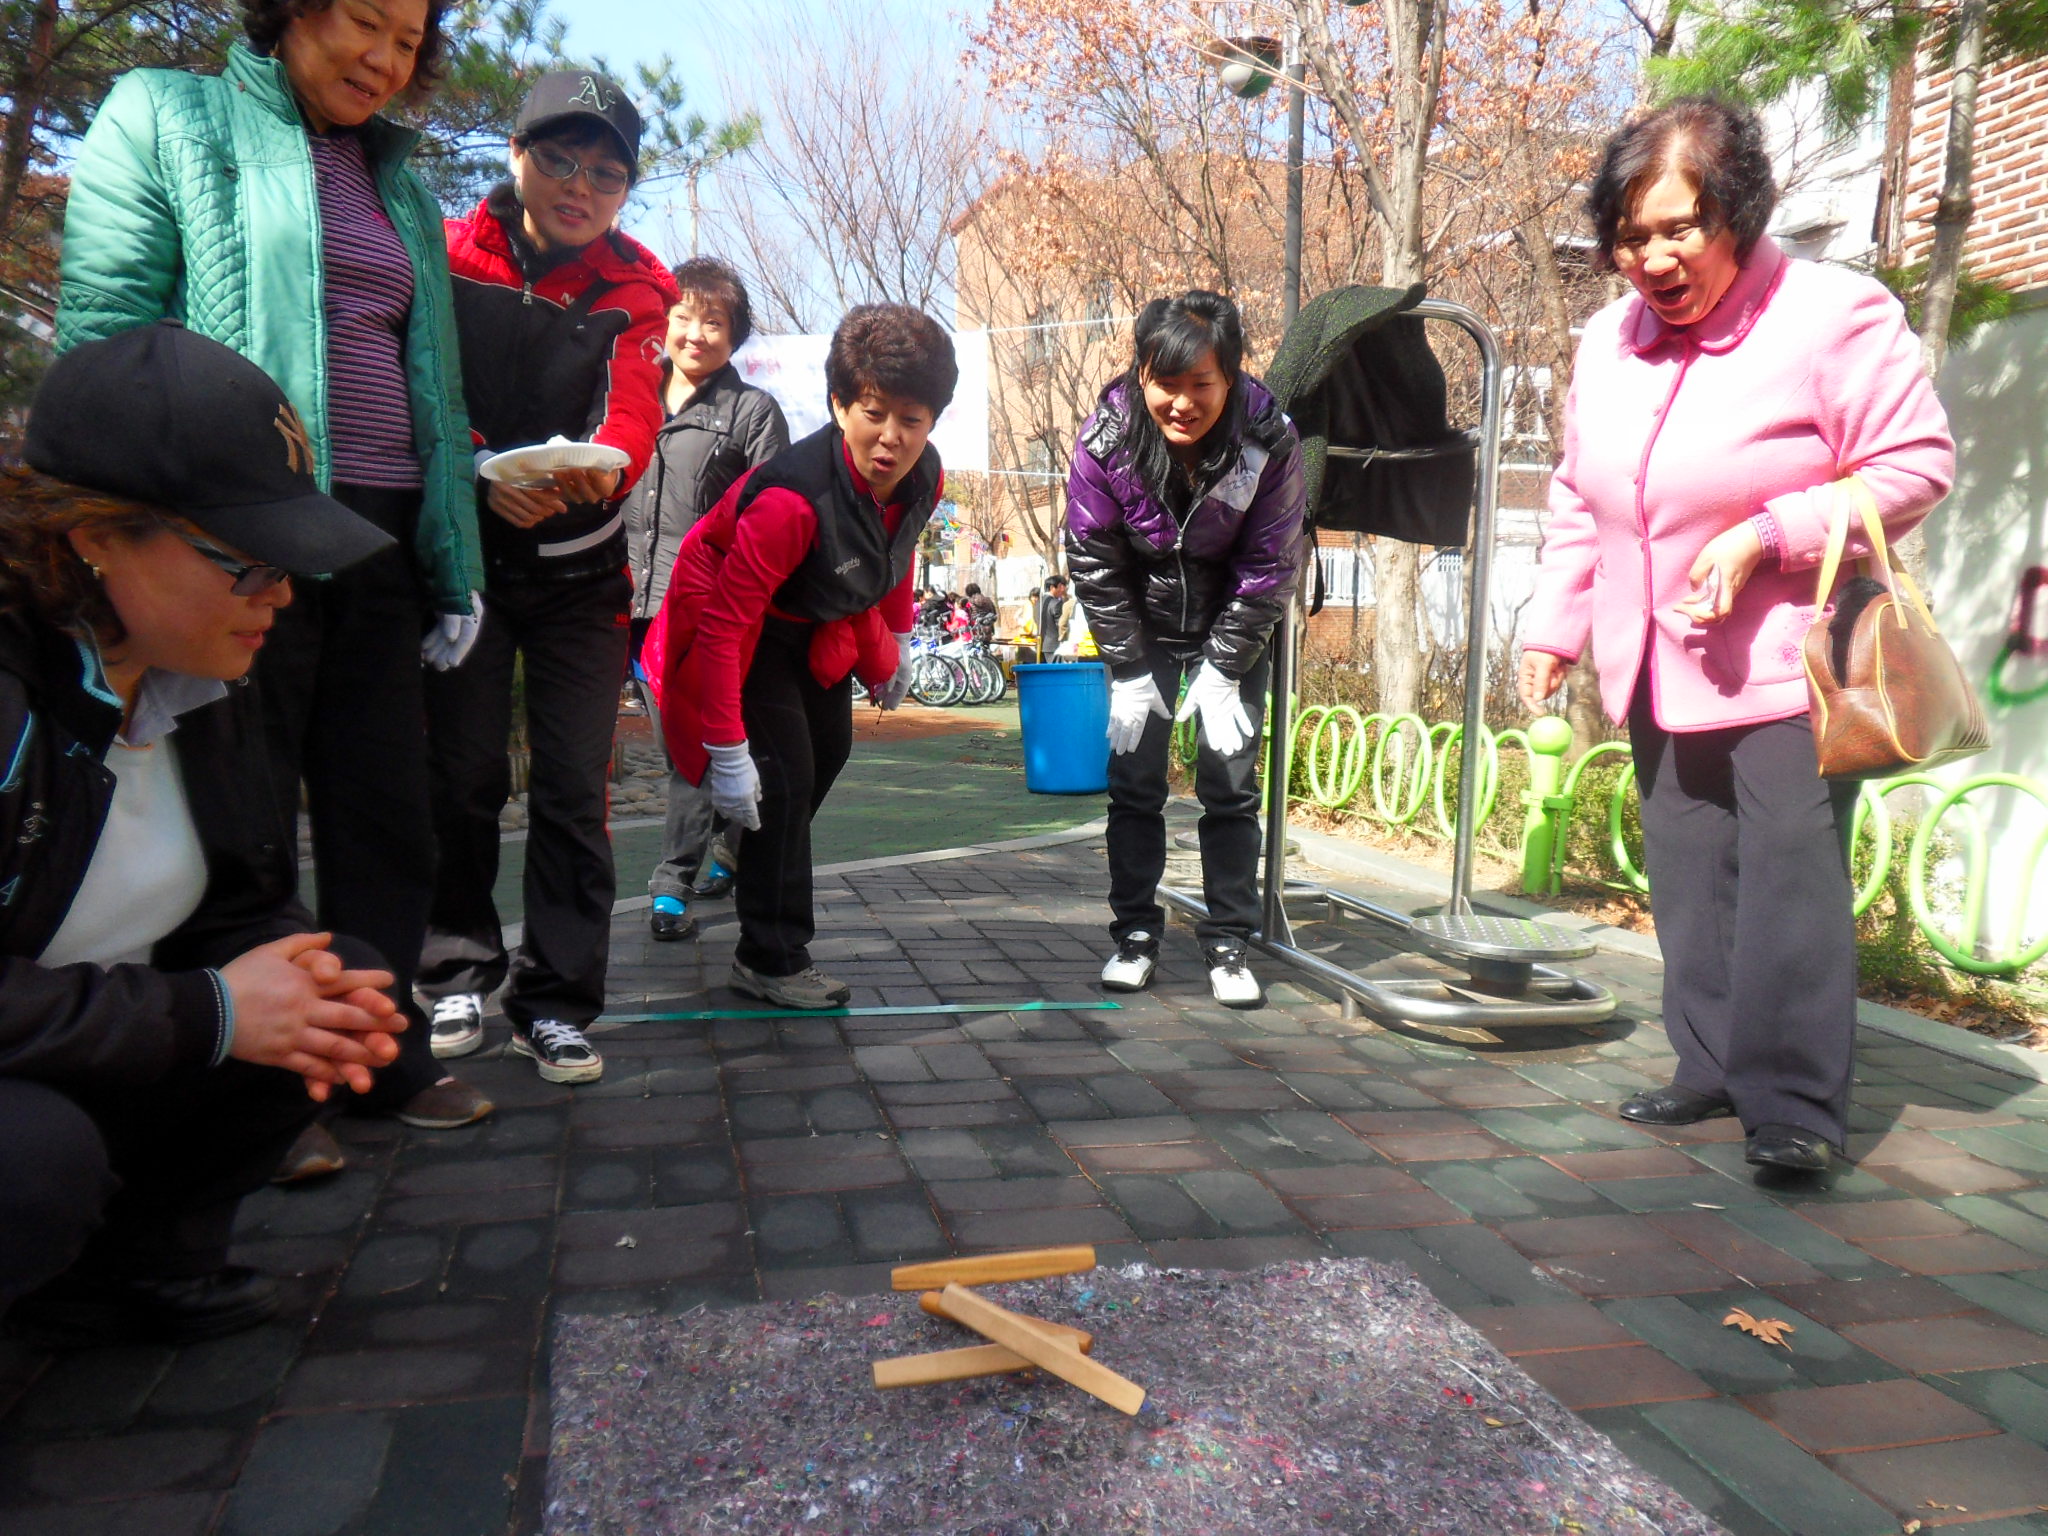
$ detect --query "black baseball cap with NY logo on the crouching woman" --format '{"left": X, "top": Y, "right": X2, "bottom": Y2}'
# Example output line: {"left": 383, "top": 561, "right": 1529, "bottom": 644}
{"left": 23, "top": 319, "right": 395, "bottom": 575}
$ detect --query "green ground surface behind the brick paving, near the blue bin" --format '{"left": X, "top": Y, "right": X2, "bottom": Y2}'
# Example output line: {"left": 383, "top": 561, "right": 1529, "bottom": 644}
{"left": 496, "top": 708, "right": 1106, "bottom": 924}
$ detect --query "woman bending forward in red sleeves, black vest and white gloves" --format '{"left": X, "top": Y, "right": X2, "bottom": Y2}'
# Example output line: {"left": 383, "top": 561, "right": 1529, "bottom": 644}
{"left": 659, "top": 303, "right": 961, "bottom": 1008}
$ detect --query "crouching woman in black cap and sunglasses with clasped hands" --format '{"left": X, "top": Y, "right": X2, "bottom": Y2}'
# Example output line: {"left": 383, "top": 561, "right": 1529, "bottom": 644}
{"left": 0, "top": 324, "right": 403, "bottom": 1341}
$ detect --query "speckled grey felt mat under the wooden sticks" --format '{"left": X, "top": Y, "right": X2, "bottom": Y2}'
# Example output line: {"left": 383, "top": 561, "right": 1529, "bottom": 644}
{"left": 545, "top": 1260, "right": 1718, "bottom": 1536}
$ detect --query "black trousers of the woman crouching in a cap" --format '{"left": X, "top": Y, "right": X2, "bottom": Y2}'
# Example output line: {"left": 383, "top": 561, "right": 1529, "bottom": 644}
{"left": 0, "top": 1061, "right": 317, "bottom": 1313}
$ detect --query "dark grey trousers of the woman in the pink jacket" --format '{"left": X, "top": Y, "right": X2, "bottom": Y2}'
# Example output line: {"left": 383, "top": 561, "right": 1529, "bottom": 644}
{"left": 1628, "top": 668, "right": 1858, "bottom": 1147}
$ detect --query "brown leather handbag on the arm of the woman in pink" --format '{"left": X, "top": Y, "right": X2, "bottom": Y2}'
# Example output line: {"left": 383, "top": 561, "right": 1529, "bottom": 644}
{"left": 1806, "top": 475, "right": 1991, "bottom": 778}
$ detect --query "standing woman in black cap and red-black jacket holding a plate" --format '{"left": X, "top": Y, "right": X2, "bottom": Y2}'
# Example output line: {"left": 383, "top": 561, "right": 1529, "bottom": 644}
{"left": 421, "top": 69, "right": 676, "bottom": 1083}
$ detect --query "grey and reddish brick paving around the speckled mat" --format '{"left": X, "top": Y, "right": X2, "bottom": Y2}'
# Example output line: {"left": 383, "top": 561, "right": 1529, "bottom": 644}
{"left": 12, "top": 811, "right": 2048, "bottom": 1536}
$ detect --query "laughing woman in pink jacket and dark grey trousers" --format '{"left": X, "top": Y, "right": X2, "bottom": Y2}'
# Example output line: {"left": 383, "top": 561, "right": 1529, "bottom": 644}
{"left": 1520, "top": 96, "right": 1954, "bottom": 1174}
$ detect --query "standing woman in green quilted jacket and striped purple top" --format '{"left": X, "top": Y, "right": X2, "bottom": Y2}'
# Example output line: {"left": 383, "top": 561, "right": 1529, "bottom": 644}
{"left": 57, "top": 0, "right": 492, "bottom": 1146}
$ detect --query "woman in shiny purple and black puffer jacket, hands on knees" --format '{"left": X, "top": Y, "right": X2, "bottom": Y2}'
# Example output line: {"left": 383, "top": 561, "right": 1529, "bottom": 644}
{"left": 1067, "top": 289, "right": 1305, "bottom": 1008}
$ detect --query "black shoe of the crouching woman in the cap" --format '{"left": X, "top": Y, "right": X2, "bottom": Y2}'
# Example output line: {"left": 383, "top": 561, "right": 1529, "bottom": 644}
{"left": 8, "top": 1264, "right": 276, "bottom": 1343}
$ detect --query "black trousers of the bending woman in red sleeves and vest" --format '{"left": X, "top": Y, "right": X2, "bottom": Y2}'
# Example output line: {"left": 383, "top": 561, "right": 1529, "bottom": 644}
{"left": 733, "top": 618, "right": 854, "bottom": 977}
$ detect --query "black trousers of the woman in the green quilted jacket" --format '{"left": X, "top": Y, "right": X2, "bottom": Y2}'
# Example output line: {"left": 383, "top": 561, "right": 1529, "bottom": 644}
{"left": 256, "top": 485, "right": 444, "bottom": 1110}
